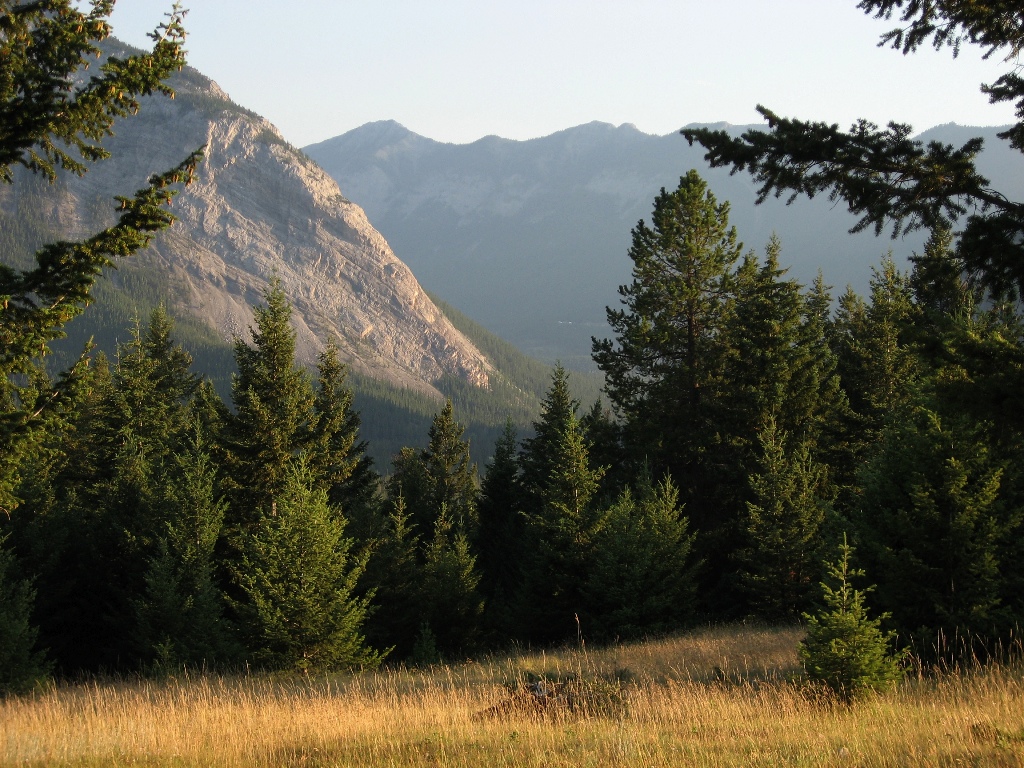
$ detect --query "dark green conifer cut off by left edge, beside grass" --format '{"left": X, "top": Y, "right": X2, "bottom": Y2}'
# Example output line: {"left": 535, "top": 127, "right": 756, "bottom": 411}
{"left": 0, "top": 537, "right": 50, "bottom": 697}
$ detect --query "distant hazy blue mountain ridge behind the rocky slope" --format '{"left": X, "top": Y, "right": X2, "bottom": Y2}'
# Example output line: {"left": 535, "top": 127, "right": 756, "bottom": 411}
{"left": 304, "top": 121, "right": 1024, "bottom": 368}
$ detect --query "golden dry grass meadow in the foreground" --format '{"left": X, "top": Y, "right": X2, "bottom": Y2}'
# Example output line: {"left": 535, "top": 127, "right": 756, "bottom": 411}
{"left": 0, "top": 627, "right": 1024, "bottom": 768}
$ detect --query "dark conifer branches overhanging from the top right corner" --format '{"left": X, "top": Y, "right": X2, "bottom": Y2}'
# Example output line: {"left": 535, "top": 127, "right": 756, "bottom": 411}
{"left": 682, "top": 0, "right": 1024, "bottom": 301}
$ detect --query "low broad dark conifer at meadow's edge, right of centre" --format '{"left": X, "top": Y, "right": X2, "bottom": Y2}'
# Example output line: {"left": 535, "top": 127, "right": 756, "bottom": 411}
{"left": 582, "top": 474, "right": 696, "bottom": 641}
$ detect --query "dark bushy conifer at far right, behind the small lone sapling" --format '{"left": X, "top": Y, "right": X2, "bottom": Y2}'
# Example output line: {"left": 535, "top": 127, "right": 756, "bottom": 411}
{"left": 856, "top": 406, "right": 1021, "bottom": 656}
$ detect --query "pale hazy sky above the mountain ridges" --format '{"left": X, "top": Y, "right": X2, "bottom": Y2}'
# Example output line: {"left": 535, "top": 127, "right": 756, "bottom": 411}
{"left": 105, "top": 0, "right": 1013, "bottom": 146}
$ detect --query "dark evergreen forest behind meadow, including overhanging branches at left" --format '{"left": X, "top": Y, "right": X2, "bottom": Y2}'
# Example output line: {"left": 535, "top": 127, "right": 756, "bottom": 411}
{"left": 0, "top": 3, "right": 1024, "bottom": 691}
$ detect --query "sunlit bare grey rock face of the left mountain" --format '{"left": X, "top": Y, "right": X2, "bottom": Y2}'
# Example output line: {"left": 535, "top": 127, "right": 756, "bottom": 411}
{"left": 22, "top": 49, "right": 490, "bottom": 391}
